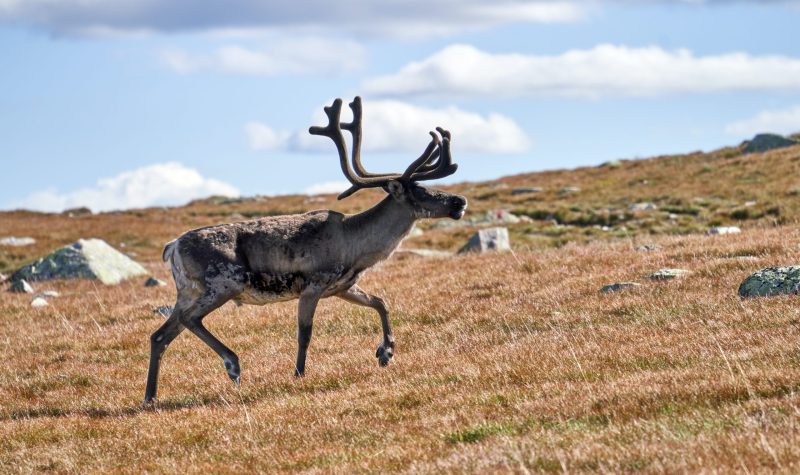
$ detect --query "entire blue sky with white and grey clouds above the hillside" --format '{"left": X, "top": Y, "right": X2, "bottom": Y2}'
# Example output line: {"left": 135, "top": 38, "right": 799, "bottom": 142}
{"left": 0, "top": 0, "right": 800, "bottom": 211}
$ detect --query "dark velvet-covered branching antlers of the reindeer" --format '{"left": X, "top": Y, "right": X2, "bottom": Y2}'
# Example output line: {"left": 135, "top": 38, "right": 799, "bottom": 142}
{"left": 308, "top": 96, "right": 458, "bottom": 200}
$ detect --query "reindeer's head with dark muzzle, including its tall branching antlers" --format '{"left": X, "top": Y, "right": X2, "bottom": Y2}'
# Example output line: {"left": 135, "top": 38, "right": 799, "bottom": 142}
{"left": 308, "top": 96, "right": 467, "bottom": 223}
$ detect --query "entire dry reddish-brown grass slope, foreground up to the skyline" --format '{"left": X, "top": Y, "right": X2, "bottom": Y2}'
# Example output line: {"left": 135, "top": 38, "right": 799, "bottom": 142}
{"left": 0, "top": 143, "right": 800, "bottom": 473}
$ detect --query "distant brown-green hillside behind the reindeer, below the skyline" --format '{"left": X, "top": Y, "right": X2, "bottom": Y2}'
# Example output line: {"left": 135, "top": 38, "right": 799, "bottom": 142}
{"left": 0, "top": 140, "right": 800, "bottom": 272}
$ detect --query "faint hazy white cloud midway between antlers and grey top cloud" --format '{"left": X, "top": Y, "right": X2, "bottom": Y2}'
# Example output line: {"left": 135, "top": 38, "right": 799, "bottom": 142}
{"left": 161, "top": 37, "right": 366, "bottom": 76}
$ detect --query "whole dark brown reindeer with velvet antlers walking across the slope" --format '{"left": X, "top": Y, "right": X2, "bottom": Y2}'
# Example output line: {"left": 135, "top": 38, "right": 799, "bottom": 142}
{"left": 144, "top": 97, "right": 467, "bottom": 403}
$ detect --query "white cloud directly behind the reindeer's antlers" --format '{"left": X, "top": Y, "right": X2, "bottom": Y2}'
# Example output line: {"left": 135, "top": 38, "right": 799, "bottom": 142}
{"left": 245, "top": 100, "right": 531, "bottom": 153}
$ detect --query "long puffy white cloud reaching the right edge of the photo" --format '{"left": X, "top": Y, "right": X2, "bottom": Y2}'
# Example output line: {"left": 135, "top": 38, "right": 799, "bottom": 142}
{"left": 363, "top": 44, "right": 800, "bottom": 97}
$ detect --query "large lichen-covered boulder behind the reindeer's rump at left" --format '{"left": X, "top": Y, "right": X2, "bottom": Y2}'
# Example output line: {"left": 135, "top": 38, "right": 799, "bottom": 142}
{"left": 11, "top": 239, "right": 147, "bottom": 285}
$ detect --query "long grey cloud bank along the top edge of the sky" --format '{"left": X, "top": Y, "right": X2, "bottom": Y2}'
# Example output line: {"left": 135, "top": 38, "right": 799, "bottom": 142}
{"left": 0, "top": 0, "right": 584, "bottom": 37}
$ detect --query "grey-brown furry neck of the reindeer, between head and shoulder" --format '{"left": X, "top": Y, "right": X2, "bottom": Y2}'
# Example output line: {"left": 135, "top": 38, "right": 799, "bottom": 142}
{"left": 345, "top": 196, "right": 416, "bottom": 265}
